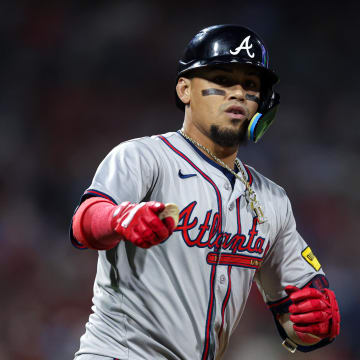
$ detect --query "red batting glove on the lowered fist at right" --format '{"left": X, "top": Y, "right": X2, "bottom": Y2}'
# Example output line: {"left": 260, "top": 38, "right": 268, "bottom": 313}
{"left": 285, "top": 285, "right": 340, "bottom": 343}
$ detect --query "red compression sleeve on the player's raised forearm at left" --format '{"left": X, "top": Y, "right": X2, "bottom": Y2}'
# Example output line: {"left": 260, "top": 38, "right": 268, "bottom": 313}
{"left": 73, "top": 197, "right": 121, "bottom": 250}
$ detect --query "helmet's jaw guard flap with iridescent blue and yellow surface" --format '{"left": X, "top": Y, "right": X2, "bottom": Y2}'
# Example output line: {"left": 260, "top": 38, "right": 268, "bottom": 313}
{"left": 248, "top": 90, "right": 280, "bottom": 143}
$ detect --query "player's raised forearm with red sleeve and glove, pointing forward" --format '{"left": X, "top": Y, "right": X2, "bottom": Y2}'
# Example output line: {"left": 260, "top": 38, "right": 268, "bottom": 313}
{"left": 72, "top": 197, "right": 179, "bottom": 250}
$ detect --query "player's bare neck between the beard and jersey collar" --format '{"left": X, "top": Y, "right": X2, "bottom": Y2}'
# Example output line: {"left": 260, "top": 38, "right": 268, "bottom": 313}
{"left": 182, "top": 123, "right": 238, "bottom": 169}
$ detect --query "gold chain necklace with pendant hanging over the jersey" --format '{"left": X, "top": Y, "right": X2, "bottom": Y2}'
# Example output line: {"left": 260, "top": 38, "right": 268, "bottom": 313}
{"left": 180, "top": 129, "right": 266, "bottom": 224}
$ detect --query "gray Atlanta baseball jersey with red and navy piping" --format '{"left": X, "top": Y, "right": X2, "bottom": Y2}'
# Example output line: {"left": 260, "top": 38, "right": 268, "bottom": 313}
{"left": 74, "top": 132, "right": 324, "bottom": 360}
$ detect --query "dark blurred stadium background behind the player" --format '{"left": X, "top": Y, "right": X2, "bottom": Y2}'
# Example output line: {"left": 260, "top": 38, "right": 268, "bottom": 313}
{"left": 0, "top": 0, "right": 360, "bottom": 360}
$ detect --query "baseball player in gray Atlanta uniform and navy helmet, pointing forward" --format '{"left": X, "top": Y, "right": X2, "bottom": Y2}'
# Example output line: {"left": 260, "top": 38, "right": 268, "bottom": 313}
{"left": 71, "top": 25, "right": 340, "bottom": 360}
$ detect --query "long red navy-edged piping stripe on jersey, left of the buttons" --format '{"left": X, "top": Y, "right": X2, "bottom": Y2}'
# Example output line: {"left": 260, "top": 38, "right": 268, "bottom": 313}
{"left": 159, "top": 136, "right": 222, "bottom": 360}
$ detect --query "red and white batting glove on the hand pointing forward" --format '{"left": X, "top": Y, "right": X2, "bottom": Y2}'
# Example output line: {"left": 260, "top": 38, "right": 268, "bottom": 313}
{"left": 112, "top": 201, "right": 174, "bottom": 249}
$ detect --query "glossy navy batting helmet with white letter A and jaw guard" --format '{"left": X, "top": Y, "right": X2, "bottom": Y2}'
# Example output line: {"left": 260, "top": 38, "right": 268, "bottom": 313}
{"left": 175, "top": 25, "right": 280, "bottom": 142}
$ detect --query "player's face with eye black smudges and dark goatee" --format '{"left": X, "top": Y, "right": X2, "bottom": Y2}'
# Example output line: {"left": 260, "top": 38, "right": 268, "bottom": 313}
{"left": 184, "top": 64, "right": 261, "bottom": 146}
